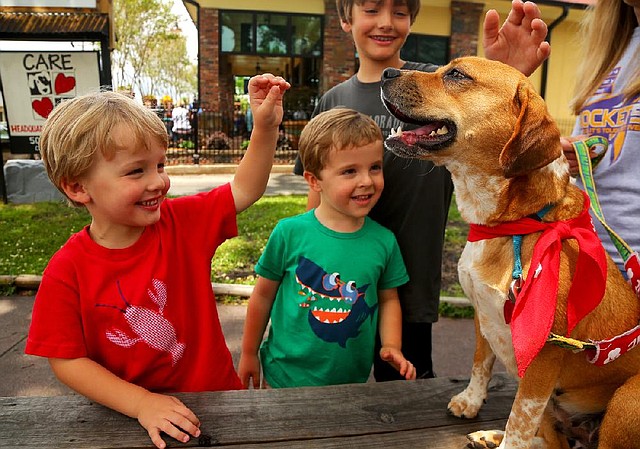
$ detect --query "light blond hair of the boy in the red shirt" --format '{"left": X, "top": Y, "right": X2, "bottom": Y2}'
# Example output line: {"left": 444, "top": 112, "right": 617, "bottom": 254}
{"left": 40, "top": 91, "right": 169, "bottom": 206}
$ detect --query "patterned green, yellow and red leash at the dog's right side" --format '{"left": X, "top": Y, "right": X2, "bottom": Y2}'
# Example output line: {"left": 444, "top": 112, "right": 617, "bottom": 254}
{"left": 548, "top": 136, "right": 640, "bottom": 366}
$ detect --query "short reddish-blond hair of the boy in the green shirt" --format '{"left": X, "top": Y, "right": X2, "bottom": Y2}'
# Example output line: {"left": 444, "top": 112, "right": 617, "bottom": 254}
{"left": 298, "top": 108, "right": 382, "bottom": 178}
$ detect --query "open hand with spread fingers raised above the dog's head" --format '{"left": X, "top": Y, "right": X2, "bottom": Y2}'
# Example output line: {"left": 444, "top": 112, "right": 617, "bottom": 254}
{"left": 482, "top": 0, "right": 551, "bottom": 76}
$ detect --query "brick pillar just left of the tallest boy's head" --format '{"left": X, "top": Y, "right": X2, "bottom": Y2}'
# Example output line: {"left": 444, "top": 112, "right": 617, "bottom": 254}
{"left": 320, "top": 0, "right": 356, "bottom": 94}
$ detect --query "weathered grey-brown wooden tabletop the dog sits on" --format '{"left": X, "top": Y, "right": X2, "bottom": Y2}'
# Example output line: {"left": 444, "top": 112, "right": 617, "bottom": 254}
{"left": 0, "top": 374, "right": 516, "bottom": 449}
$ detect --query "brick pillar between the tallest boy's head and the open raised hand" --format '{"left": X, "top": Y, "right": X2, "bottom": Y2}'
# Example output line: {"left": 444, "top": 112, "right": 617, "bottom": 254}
{"left": 449, "top": 1, "right": 484, "bottom": 59}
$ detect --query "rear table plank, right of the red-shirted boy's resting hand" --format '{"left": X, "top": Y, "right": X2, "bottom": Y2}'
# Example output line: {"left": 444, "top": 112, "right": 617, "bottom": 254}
{"left": 188, "top": 376, "right": 515, "bottom": 444}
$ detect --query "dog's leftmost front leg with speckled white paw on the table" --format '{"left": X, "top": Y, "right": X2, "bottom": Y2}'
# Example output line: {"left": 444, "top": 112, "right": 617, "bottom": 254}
{"left": 448, "top": 313, "right": 496, "bottom": 418}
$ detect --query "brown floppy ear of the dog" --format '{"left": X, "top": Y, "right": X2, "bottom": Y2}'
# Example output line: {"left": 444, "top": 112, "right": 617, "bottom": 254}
{"left": 499, "top": 81, "right": 562, "bottom": 178}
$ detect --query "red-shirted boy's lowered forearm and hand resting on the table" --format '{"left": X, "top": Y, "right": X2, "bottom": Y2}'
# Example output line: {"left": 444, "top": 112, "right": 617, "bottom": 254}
{"left": 49, "top": 357, "right": 200, "bottom": 449}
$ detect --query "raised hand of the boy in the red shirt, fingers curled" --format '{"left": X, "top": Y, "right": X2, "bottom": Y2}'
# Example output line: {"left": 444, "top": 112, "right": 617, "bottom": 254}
{"left": 249, "top": 73, "right": 291, "bottom": 129}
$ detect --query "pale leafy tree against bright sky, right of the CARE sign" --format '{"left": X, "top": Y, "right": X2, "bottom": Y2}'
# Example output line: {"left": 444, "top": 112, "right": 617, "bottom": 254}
{"left": 112, "top": 0, "right": 197, "bottom": 100}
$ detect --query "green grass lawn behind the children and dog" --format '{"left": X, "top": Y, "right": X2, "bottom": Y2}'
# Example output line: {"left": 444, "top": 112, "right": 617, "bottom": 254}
{"left": 0, "top": 195, "right": 469, "bottom": 316}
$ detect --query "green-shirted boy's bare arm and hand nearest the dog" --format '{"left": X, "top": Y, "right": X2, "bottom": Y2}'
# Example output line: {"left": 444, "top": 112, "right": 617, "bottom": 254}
{"left": 378, "top": 288, "right": 416, "bottom": 380}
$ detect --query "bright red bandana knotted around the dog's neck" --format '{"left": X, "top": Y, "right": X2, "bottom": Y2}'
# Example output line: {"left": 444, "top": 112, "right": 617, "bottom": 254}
{"left": 467, "top": 194, "right": 607, "bottom": 377}
